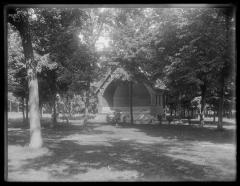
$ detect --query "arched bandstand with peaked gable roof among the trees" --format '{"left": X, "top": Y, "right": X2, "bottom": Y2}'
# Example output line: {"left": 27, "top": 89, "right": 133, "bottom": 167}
{"left": 95, "top": 65, "right": 166, "bottom": 123}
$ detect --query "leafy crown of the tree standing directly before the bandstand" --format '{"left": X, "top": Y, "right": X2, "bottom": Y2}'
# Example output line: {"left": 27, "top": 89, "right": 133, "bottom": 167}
{"left": 108, "top": 8, "right": 188, "bottom": 123}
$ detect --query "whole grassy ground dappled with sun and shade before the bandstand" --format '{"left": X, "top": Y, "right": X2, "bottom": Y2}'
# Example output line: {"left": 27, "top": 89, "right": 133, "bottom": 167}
{"left": 7, "top": 113, "right": 236, "bottom": 182}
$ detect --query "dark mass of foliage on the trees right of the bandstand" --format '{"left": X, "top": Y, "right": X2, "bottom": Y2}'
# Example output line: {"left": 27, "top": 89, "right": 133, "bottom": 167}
{"left": 161, "top": 8, "right": 234, "bottom": 123}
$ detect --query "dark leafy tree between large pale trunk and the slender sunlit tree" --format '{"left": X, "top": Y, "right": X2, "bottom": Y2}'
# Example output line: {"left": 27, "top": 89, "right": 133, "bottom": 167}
{"left": 29, "top": 8, "right": 86, "bottom": 125}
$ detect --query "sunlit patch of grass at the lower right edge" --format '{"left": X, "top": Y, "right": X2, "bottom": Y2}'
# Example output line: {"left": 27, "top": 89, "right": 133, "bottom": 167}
{"left": 166, "top": 142, "right": 236, "bottom": 178}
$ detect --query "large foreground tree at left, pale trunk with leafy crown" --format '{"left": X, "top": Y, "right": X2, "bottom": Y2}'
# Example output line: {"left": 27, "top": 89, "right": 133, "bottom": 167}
{"left": 8, "top": 8, "right": 90, "bottom": 148}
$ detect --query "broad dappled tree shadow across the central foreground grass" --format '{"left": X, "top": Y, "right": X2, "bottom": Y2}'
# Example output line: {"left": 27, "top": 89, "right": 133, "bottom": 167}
{"left": 8, "top": 141, "right": 218, "bottom": 181}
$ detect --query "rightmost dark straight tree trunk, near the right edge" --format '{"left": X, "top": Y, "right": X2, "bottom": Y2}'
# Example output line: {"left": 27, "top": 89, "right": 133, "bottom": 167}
{"left": 217, "top": 76, "right": 224, "bottom": 129}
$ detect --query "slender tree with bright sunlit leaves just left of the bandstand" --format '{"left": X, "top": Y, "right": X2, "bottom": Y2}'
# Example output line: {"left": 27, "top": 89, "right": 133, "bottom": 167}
{"left": 75, "top": 8, "right": 112, "bottom": 124}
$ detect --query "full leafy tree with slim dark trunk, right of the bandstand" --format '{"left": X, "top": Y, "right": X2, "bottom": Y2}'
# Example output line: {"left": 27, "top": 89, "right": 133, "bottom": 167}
{"left": 163, "top": 8, "right": 234, "bottom": 126}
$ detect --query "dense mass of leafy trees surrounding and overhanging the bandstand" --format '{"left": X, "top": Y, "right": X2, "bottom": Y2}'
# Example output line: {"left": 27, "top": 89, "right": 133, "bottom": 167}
{"left": 8, "top": 8, "right": 235, "bottom": 140}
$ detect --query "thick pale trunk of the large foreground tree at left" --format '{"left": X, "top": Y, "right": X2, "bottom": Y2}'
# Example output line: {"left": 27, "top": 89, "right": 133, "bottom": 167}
{"left": 8, "top": 8, "right": 43, "bottom": 148}
